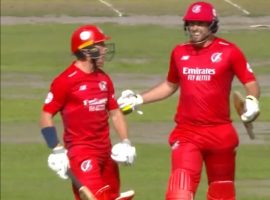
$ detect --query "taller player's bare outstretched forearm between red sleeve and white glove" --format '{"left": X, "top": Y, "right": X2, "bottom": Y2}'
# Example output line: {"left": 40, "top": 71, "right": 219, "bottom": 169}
{"left": 141, "top": 80, "right": 178, "bottom": 104}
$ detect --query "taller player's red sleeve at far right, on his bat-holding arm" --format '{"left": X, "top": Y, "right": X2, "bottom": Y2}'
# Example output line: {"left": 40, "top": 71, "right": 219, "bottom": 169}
{"left": 231, "top": 46, "right": 256, "bottom": 84}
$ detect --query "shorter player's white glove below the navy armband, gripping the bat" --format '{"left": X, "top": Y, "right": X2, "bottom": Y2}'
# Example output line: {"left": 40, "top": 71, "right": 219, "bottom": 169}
{"left": 48, "top": 146, "right": 69, "bottom": 179}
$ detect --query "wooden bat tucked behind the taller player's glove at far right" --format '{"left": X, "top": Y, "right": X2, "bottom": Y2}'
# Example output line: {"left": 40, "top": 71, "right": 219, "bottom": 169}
{"left": 233, "top": 91, "right": 255, "bottom": 140}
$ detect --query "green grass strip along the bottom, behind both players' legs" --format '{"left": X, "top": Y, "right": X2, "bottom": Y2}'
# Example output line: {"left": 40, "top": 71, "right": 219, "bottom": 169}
{"left": 1, "top": 143, "right": 270, "bottom": 200}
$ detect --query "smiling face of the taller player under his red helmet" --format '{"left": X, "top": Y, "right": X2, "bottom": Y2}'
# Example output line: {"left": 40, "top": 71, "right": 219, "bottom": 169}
{"left": 187, "top": 21, "right": 211, "bottom": 43}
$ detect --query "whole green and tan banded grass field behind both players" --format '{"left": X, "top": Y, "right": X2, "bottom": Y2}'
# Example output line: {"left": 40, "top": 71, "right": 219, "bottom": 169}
{"left": 1, "top": 0, "right": 270, "bottom": 200}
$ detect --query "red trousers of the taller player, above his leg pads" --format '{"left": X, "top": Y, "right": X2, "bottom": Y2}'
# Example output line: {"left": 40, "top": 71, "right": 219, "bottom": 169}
{"left": 169, "top": 123, "right": 239, "bottom": 193}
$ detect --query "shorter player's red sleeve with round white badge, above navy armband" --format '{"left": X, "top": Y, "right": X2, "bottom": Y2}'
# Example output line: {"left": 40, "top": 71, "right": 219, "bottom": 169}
{"left": 43, "top": 77, "right": 68, "bottom": 115}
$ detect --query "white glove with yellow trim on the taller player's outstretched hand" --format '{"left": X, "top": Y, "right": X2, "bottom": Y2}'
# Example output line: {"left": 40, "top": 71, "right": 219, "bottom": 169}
{"left": 117, "top": 90, "right": 143, "bottom": 115}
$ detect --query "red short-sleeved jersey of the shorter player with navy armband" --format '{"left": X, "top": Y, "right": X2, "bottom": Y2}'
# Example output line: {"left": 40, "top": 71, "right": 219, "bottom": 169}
{"left": 43, "top": 64, "right": 118, "bottom": 152}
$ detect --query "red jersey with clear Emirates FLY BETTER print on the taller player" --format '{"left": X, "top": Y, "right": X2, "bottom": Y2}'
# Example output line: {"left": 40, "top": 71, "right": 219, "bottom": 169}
{"left": 167, "top": 38, "right": 255, "bottom": 125}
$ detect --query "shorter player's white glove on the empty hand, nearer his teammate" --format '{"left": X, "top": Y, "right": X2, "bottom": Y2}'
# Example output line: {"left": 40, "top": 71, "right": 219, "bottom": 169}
{"left": 111, "top": 139, "right": 136, "bottom": 165}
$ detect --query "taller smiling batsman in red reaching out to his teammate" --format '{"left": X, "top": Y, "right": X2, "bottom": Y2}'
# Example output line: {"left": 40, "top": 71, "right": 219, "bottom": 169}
{"left": 118, "top": 1, "right": 260, "bottom": 200}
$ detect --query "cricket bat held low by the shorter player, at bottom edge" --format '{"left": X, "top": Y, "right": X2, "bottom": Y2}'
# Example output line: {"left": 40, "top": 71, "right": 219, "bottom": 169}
{"left": 67, "top": 169, "right": 97, "bottom": 200}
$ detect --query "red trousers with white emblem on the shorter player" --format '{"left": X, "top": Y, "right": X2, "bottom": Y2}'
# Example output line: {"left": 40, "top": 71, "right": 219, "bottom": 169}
{"left": 68, "top": 146, "right": 120, "bottom": 200}
